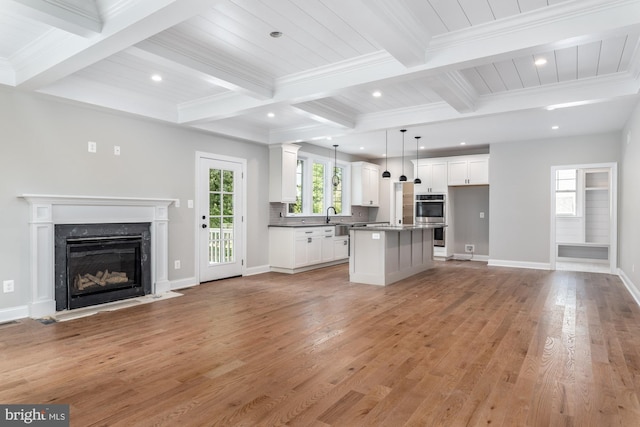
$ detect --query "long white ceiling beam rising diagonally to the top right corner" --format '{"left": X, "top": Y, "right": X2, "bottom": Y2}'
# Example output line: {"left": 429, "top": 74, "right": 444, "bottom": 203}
{"left": 180, "top": 0, "right": 640, "bottom": 123}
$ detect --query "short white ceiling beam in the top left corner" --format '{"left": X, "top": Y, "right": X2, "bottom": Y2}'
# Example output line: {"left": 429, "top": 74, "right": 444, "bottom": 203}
{"left": 7, "top": 0, "right": 102, "bottom": 37}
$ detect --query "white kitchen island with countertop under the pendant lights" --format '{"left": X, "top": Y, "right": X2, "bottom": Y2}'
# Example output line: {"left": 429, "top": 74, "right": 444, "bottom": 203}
{"left": 349, "top": 224, "right": 446, "bottom": 286}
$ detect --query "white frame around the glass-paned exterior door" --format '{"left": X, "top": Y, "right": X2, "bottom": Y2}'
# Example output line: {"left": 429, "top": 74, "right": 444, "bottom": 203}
{"left": 194, "top": 151, "right": 247, "bottom": 285}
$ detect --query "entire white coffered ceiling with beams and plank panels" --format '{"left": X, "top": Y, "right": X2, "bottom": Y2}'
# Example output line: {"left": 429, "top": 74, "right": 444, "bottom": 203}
{"left": 0, "top": 0, "right": 640, "bottom": 158}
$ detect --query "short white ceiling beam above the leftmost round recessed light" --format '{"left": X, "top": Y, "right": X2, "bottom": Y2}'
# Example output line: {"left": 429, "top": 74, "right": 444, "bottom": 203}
{"left": 136, "top": 37, "right": 273, "bottom": 99}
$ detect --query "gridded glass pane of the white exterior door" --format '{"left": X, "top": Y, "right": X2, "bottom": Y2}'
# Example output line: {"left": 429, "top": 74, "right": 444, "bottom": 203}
{"left": 209, "top": 169, "right": 235, "bottom": 264}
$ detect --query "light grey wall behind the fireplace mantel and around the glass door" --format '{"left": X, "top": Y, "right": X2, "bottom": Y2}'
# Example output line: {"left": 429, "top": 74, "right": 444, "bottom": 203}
{"left": 0, "top": 87, "right": 269, "bottom": 316}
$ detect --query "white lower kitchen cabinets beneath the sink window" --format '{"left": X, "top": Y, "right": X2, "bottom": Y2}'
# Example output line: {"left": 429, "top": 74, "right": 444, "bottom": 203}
{"left": 269, "top": 226, "right": 349, "bottom": 273}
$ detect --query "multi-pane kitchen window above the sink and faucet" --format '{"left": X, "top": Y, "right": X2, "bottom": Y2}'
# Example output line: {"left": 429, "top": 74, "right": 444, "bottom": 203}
{"left": 287, "top": 152, "right": 351, "bottom": 216}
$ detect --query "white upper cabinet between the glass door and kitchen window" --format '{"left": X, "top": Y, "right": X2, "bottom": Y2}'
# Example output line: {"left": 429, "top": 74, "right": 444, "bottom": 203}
{"left": 269, "top": 144, "right": 300, "bottom": 203}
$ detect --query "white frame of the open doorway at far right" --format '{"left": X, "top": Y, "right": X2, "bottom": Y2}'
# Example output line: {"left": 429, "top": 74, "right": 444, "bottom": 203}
{"left": 549, "top": 162, "right": 618, "bottom": 274}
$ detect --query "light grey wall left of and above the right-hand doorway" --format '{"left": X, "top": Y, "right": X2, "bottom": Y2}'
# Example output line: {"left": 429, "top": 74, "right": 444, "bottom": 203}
{"left": 489, "top": 131, "right": 620, "bottom": 268}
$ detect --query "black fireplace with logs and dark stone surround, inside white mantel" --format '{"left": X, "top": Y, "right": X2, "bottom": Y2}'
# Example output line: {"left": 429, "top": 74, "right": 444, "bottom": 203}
{"left": 55, "top": 223, "right": 151, "bottom": 311}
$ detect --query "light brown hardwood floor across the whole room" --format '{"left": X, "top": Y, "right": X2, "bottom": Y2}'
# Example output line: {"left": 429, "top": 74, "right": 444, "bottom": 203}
{"left": 0, "top": 262, "right": 640, "bottom": 426}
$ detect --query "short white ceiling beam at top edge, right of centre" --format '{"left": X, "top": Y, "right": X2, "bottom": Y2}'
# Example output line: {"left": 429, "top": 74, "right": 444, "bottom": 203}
{"left": 325, "top": 0, "right": 431, "bottom": 67}
